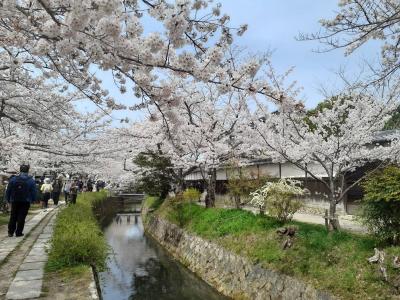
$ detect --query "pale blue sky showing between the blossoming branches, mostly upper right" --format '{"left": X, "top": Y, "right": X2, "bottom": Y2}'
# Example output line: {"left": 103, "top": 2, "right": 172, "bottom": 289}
{"left": 91, "top": 0, "right": 379, "bottom": 123}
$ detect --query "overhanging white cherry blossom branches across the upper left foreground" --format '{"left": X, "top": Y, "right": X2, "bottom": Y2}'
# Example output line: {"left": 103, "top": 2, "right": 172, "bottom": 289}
{"left": 0, "top": 0, "right": 279, "bottom": 118}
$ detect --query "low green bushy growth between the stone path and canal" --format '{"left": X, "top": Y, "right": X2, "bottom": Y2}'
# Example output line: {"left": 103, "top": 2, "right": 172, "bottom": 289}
{"left": 46, "top": 192, "right": 108, "bottom": 271}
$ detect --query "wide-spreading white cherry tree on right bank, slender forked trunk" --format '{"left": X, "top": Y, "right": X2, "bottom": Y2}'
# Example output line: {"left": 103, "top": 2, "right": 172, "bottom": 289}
{"left": 247, "top": 91, "right": 399, "bottom": 229}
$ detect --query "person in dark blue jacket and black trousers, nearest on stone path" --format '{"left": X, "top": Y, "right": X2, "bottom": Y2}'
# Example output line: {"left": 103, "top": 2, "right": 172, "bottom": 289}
{"left": 6, "top": 165, "right": 36, "bottom": 237}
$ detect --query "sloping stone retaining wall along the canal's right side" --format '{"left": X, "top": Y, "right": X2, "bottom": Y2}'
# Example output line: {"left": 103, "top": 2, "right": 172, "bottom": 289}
{"left": 144, "top": 215, "right": 336, "bottom": 300}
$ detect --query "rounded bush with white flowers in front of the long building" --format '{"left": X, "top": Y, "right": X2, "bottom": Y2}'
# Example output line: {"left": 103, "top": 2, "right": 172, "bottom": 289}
{"left": 250, "top": 179, "right": 308, "bottom": 222}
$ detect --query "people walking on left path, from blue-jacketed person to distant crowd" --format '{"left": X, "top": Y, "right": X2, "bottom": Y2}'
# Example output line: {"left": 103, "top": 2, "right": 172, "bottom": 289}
{"left": 5, "top": 164, "right": 104, "bottom": 237}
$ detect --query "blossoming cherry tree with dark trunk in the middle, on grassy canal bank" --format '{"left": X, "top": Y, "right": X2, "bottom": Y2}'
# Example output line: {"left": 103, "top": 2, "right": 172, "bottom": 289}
{"left": 153, "top": 85, "right": 250, "bottom": 207}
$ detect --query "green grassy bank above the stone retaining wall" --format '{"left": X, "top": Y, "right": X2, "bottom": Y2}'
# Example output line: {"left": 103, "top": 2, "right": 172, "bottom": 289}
{"left": 156, "top": 201, "right": 400, "bottom": 299}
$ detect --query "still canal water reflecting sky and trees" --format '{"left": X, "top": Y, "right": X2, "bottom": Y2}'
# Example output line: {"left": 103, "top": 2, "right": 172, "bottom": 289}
{"left": 99, "top": 215, "right": 227, "bottom": 300}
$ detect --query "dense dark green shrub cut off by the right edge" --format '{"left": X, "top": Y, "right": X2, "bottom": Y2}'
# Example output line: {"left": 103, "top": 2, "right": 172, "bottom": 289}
{"left": 361, "top": 166, "right": 400, "bottom": 244}
